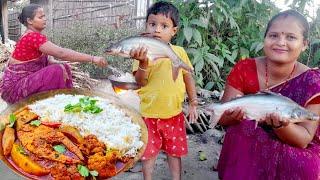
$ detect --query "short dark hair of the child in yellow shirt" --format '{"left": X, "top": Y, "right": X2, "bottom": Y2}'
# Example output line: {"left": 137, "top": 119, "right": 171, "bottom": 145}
{"left": 146, "top": 1, "right": 180, "bottom": 27}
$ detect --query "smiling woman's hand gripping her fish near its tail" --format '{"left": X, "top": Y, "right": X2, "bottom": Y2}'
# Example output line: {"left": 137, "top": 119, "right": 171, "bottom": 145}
{"left": 220, "top": 107, "right": 244, "bottom": 124}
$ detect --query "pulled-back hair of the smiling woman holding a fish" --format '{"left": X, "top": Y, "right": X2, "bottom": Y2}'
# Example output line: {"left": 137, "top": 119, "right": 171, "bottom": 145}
{"left": 264, "top": 9, "right": 309, "bottom": 40}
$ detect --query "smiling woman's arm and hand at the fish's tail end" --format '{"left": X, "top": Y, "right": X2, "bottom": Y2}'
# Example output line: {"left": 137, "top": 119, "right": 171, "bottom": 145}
{"left": 219, "top": 84, "right": 244, "bottom": 126}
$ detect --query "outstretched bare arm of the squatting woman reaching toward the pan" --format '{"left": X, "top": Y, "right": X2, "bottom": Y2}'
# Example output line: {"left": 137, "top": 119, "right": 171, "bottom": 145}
{"left": 39, "top": 41, "right": 107, "bottom": 67}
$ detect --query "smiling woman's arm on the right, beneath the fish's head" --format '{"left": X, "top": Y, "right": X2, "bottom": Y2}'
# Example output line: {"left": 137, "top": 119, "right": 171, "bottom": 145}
{"left": 274, "top": 104, "right": 320, "bottom": 148}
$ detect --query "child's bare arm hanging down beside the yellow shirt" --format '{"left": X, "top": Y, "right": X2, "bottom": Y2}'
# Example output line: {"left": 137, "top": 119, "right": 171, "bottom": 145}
{"left": 183, "top": 73, "right": 198, "bottom": 123}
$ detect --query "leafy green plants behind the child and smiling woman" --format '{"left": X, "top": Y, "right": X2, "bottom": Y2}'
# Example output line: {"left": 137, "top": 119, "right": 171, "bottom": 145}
{"left": 159, "top": 0, "right": 320, "bottom": 90}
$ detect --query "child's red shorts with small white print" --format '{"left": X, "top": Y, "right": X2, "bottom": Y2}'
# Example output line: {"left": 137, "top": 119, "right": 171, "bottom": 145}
{"left": 142, "top": 112, "right": 188, "bottom": 160}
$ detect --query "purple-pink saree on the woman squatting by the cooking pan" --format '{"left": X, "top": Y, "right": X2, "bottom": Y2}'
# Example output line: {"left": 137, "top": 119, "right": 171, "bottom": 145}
{"left": 0, "top": 56, "right": 72, "bottom": 103}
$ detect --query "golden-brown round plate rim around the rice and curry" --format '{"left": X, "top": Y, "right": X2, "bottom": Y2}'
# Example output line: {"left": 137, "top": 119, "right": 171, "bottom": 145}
{"left": 0, "top": 89, "right": 148, "bottom": 179}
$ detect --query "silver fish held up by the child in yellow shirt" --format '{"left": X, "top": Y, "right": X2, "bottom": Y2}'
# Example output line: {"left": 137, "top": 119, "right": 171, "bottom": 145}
{"left": 105, "top": 36, "right": 193, "bottom": 81}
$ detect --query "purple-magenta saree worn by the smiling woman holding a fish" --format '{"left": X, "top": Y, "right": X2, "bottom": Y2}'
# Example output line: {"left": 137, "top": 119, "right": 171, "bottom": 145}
{"left": 218, "top": 69, "right": 320, "bottom": 180}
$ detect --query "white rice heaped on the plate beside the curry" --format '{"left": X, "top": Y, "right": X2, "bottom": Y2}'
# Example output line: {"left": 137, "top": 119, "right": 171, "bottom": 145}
{"left": 29, "top": 94, "right": 143, "bottom": 157}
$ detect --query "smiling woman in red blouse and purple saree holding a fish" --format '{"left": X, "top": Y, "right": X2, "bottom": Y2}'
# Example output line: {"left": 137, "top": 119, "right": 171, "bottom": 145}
{"left": 218, "top": 10, "right": 320, "bottom": 180}
